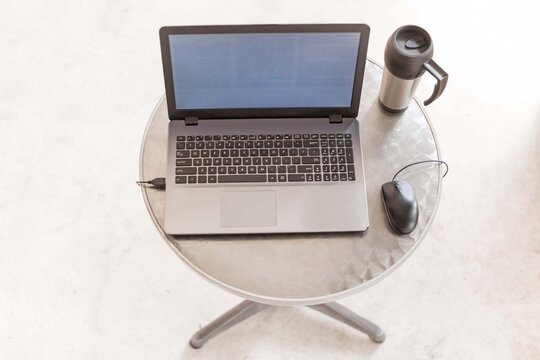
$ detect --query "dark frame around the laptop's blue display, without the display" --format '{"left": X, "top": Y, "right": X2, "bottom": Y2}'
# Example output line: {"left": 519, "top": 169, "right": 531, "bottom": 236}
{"left": 159, "top": 24, "right": 369, "bottom": 120}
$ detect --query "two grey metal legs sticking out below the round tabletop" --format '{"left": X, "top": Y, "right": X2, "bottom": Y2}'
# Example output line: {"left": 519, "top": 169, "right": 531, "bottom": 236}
{"left": 189, "top": 300, "right": 385, "bottom": 349}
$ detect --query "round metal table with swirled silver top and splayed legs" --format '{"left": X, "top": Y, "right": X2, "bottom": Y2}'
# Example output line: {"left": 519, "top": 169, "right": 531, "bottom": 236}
{"left": 140, "top": 60, "right": 442, "bottom": 347}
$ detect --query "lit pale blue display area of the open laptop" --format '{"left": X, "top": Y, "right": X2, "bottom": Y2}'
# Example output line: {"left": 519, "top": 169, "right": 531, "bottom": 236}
{"left": 168, "top": 32, "right": 361, "bottom": 109}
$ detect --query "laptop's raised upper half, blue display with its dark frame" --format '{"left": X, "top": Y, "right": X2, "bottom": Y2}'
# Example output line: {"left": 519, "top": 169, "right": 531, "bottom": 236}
{"left": 160, "top": 24, "right": 369, "bottom": 120}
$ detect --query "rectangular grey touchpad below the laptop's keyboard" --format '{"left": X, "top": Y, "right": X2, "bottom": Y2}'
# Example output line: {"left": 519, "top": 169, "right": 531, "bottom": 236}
{"left": 221, "top": 191, "right": 276, "bottom": 227}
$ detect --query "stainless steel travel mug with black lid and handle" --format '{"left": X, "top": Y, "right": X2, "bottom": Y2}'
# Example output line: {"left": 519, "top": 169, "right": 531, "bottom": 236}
{"left": 379, "top": 25, "right": 448, "bottom": 112}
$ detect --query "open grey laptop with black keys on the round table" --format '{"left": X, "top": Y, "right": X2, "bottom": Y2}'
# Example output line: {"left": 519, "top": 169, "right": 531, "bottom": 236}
{"left": 160, "top": 24, "right": 369, "bottom": 235}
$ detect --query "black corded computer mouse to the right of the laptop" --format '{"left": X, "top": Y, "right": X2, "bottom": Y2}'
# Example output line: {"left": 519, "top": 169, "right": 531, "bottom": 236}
{"left": 381, "top": 180, "right": 418, "bottom": 234}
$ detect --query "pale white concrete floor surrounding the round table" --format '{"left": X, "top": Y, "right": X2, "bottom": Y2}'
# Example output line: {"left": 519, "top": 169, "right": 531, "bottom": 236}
{"left": 0, "top": 0, "right": 540, "bottom": 360}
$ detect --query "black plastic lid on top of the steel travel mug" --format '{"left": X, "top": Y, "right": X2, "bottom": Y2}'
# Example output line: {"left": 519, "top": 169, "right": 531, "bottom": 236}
{"left": 384, "top": 25, "right": 433, "bottom": 79}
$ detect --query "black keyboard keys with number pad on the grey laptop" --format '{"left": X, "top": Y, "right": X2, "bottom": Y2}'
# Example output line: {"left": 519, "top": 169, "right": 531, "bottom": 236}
{"left": 175, "top": 134, "right": 356, "bottom": 184}
